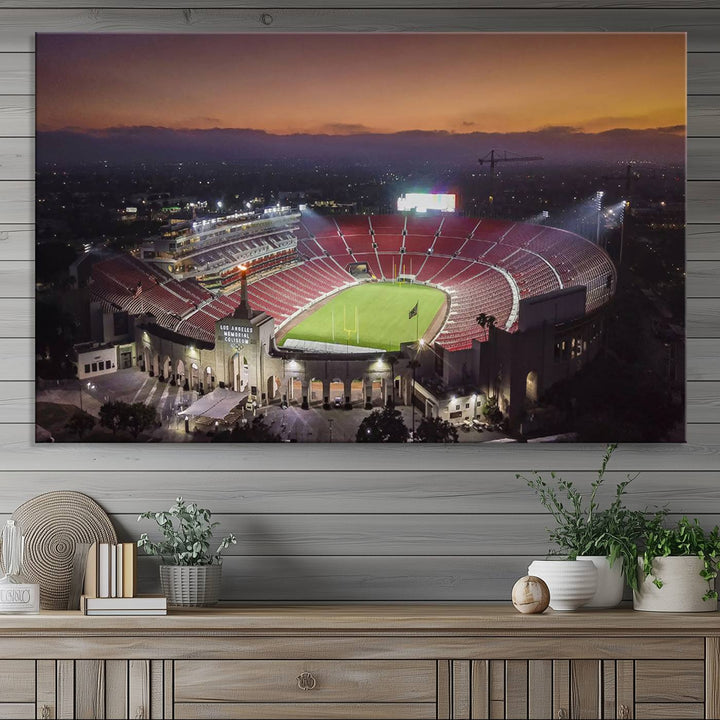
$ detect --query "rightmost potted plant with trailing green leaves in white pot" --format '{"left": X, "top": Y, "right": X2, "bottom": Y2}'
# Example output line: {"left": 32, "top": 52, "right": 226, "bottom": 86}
{"left": 633, "top": 517, "right": 720, "bottom": 612}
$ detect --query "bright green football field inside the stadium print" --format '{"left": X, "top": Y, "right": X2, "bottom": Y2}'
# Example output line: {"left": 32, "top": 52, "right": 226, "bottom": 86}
{"left": 283, "top": 283, "right": 445, "bottom": 350}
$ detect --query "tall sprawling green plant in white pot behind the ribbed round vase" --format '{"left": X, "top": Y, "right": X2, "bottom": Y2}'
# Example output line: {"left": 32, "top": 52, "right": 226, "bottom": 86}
{"left": 516, "top": 443, "right": 667, "bottom": 608}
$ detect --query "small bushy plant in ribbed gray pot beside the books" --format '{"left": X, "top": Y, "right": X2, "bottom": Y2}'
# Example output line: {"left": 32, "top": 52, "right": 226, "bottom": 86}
{"left": 137, "top": 497, "right": 237, "bottom": 606}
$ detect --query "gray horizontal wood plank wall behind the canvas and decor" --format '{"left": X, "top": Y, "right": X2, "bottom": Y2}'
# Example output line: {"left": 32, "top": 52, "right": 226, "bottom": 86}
{"left": 0, "top": 0, "right": 720, "bottom": 602}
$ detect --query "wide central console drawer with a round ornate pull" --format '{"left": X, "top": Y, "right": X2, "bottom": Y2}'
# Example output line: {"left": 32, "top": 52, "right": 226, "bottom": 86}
{"left": 175, "top": 660, "right": 437, "bottom": 703}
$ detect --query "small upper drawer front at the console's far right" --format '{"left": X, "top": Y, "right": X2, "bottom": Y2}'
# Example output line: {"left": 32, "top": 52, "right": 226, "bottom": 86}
{"left": 635, "top": 660, "right": 705, "bottom": 703}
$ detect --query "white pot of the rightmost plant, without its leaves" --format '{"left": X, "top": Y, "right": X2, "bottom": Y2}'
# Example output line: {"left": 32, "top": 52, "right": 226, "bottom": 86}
{"left": 633, "top": 555, "right": 717, "bottom": 612}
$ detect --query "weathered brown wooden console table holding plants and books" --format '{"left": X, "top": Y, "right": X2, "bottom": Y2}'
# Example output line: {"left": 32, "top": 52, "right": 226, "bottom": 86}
{"left": 0, "top": 605, "right": 720, "bottom": 720}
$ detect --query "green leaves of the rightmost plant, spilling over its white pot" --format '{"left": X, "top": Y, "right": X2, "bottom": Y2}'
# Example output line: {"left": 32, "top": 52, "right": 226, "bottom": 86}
{"left": 641, "top": 516, "right": 720, "bottom": 600}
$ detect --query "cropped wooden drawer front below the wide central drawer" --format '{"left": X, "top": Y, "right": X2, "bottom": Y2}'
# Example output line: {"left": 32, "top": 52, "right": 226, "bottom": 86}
{"left": 175, "top": 703, "right": 436, "bottom": 720}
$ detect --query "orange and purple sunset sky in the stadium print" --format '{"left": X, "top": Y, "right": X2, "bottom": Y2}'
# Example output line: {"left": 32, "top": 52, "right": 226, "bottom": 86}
{"left": 37, "top": 33, "right": 686, "bottom": 134}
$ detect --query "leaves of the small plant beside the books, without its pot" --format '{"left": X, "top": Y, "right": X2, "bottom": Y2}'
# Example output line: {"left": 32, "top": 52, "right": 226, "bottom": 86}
{"left": 137, "top": 497, "right": 237, "bottom": 565}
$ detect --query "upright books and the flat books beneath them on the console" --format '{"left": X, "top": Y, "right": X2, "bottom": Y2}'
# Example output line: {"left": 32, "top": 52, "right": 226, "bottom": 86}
{"left": 80, "top": 543, "right": 167, "bottom": 615}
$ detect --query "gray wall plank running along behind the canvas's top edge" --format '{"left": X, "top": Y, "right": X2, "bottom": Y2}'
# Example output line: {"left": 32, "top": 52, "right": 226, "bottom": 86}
{"left": 0, "top": 8, "right": 708, "bottom": 52}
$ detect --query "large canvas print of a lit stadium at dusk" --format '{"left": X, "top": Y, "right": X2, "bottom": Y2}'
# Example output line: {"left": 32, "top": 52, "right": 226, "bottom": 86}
{"left": 36, "top": 33, "right": 686, "bottom": 444}
